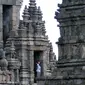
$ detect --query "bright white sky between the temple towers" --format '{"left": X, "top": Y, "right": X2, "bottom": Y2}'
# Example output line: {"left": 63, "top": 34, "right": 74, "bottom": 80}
{"left": 20, "top": 0, "right": 62, "bottom": 58}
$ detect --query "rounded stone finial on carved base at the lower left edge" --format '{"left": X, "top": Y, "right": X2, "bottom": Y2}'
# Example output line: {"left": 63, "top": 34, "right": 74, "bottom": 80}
{"left": 0, "top": 49, "right": 11, "bottom": 84}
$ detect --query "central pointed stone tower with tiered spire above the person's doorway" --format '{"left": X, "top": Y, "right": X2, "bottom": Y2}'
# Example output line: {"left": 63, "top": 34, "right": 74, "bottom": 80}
{"left": 18, "top": 0, "right": 49, "bottom": 85}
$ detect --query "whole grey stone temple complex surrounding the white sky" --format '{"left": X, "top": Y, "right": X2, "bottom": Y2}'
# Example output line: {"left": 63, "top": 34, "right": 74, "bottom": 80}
{"left": 0, "top": 0, "right": 85, "bottom": 85}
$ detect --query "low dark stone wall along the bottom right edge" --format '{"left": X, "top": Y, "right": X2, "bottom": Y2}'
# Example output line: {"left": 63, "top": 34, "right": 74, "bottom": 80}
{"left": 37, "top": 77, "right": 85, "bottom": 85}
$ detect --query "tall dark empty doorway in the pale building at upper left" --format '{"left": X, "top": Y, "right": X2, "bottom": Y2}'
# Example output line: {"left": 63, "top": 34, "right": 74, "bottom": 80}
{"left": 3, "top": 5, "right": 12, "bottom": 45}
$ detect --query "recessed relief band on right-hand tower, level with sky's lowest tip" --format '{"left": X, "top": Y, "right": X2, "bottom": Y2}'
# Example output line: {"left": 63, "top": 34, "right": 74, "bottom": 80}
{"left": 58, "top": 43, "right": 85, "bottom": 60}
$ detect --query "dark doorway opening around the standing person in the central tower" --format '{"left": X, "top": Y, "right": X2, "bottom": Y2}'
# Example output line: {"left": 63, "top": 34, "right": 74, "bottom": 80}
{"left": 34, "top": 51, "right": 43, "bottom": 83}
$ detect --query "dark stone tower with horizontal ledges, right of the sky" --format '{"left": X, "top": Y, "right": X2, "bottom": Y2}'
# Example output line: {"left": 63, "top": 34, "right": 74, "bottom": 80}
{"left": 55, "top": 0, "right": 85, "bottom": 85}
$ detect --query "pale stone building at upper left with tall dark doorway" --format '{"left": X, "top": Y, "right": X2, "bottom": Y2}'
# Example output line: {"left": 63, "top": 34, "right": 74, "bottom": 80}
{"left": 0, "top": 0, "right": 22, "bottom": 46}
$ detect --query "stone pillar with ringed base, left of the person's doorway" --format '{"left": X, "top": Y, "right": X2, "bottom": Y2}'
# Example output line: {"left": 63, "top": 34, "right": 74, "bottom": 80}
{"left": 20, "top": 46, "right": 29, "bottom": 85}
